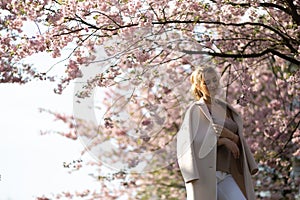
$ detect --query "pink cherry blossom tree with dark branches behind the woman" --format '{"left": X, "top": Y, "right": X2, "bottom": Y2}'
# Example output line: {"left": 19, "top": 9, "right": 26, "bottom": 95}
{"left": 0, "top": 0, "right": 300, "bottom": 199}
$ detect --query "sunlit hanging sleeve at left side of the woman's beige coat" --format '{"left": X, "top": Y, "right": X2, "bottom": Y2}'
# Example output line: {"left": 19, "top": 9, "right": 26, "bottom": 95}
{"left": 177, "top": 106, "right": 199, "bottom": 183}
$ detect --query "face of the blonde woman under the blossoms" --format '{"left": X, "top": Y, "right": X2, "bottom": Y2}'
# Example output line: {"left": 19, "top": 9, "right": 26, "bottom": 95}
{"left": 198, "top": 72, "right": 219, "bottom": 97}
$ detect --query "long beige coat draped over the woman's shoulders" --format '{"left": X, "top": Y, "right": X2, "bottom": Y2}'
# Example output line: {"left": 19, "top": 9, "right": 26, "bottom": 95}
{"left": 177, "top": 100, "right": 258, "bottom": 200}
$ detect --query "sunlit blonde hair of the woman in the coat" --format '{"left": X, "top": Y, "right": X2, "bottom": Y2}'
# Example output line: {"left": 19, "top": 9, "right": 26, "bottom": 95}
{"left": 190, "top": 67, "right": 217, "bottom": 100}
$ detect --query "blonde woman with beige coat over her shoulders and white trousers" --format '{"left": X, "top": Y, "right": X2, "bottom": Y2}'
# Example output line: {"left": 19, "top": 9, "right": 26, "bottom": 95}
{"left": 177, "top": 67, "right": 258, "bottom": 200}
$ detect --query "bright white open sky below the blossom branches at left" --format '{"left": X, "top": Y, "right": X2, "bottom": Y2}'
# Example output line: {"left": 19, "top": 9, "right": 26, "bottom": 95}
{"left": 0, "top": 82, "right": 99, "bottom": 200}
